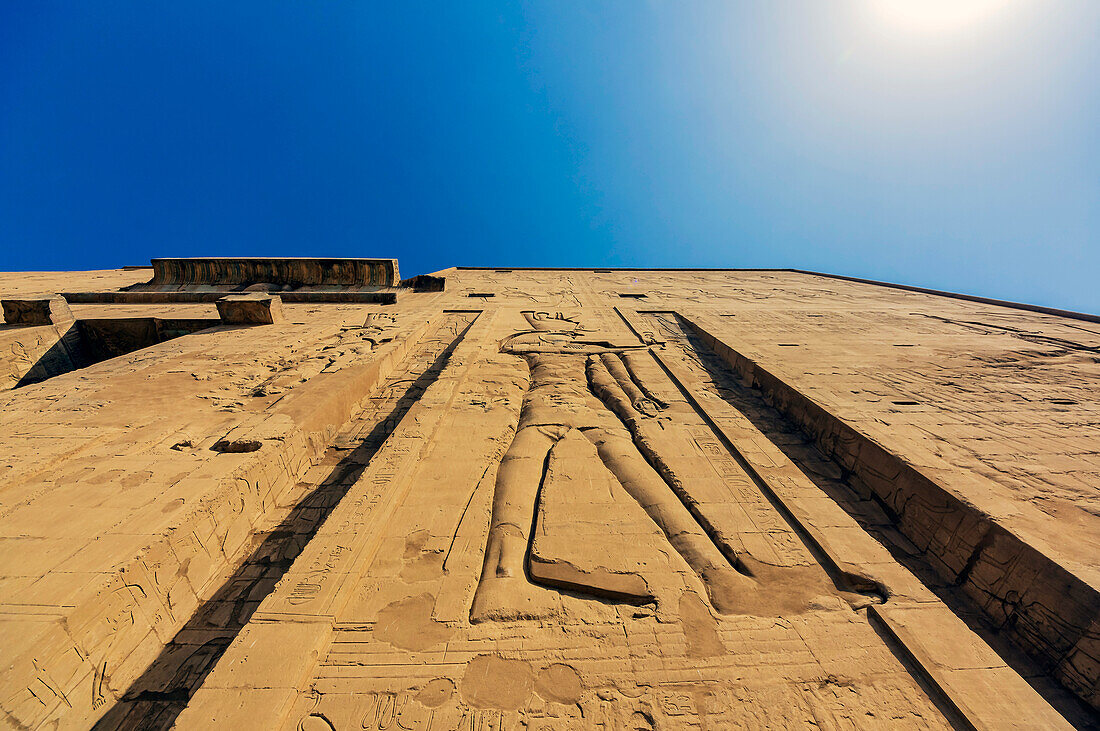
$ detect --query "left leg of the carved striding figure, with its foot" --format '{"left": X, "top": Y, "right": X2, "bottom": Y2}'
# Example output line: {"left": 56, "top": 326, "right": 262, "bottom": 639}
{"left": 471, "top": 427, "right": 557, "bottom": 622}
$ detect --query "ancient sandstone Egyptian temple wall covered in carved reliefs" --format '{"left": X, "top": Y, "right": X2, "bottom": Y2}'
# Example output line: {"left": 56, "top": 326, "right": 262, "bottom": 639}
{"left": 0, "top": 258, "right": 1100, "bottom": 731}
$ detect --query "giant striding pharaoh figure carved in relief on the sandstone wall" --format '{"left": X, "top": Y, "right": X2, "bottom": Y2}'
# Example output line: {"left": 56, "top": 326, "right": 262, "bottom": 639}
{"left": 471, "top": 312, "right": 757, "bottom": 622}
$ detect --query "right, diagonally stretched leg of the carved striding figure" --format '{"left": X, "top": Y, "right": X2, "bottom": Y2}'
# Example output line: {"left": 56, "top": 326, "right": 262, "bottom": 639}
{"left": 584, "top": 428, "right": 756, "bottom": 614}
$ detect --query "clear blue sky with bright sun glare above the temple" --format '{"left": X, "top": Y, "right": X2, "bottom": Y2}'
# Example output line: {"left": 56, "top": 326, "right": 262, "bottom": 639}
{"left": 0, "top": 0, "right": 1100, "bottom": 312}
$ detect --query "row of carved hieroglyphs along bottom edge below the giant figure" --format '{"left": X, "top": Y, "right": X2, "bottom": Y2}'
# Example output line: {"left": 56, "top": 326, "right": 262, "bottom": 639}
{"left": 292, "top": 676, "right": 945, "bottom": 731}
